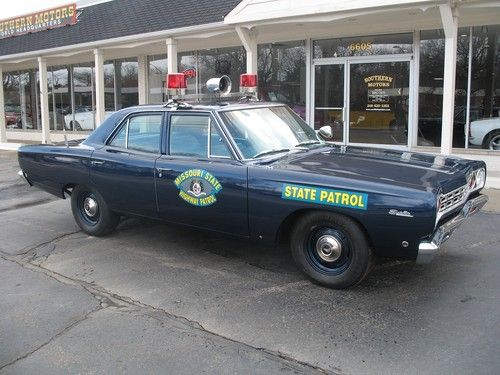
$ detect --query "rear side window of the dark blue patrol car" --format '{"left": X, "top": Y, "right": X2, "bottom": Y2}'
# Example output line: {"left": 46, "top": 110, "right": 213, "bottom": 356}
{"left": 110, "top": 114, "right": 163, "bottom": 154}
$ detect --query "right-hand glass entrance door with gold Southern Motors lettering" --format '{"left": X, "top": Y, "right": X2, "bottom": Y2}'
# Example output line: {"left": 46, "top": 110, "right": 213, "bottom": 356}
{"left": 348, "top": 61, "right": 410, "bottom": 146}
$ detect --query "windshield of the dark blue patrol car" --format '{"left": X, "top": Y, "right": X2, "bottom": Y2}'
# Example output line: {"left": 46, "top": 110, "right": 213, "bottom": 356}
{"left": 220, "top": 106, "right": 323, "bottom": 159}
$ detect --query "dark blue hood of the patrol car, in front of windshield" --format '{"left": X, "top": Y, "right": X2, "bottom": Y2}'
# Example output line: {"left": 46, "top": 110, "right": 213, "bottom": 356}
{"left": 269, "top": 145, "right": 484, "bottom": 192}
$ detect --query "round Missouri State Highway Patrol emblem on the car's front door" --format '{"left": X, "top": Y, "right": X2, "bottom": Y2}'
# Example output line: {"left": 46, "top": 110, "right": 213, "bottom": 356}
{"left": 174, "top": 169, "right": 222, "bottom": 207}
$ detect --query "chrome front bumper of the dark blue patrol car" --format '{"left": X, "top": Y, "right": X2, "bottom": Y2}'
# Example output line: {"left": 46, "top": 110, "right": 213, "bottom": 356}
{"left": 416, "top": 195, "right": 488, "bottom": 264}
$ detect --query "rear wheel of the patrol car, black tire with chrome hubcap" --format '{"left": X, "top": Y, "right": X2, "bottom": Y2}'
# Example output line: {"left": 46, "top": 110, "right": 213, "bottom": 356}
{"left": 71, "top": 185, "right": 120, "bottom": 236}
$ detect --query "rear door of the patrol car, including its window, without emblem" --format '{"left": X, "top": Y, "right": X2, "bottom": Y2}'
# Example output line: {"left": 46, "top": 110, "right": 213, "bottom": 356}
{"left": 90, "top": 112, "right": 164, "bottom": 216}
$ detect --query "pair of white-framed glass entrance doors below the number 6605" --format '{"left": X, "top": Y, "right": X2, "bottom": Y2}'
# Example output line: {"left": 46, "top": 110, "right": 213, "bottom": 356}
{"left": 313, "top": 58, "right": 411, "bottom": 147}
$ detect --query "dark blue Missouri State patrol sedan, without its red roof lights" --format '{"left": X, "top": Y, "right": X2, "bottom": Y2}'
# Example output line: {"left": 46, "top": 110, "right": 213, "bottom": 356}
{"left": 19, "top": 91, "right": 487, "bottom": 288}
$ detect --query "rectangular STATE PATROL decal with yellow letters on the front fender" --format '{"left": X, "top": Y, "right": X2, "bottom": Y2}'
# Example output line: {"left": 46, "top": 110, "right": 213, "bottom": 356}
{"left": 281, "top": 184, "right": 368, "bottom": 210}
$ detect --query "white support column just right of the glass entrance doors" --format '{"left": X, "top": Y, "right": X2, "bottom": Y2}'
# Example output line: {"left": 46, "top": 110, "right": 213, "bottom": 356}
{"left": 439, "top": 3, "right": 458, "bottom": 154}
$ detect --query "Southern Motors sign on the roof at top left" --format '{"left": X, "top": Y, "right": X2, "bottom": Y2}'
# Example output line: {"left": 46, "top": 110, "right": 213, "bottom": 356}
{"left": 0, "top": 4, "right": 76, "bottom": 39}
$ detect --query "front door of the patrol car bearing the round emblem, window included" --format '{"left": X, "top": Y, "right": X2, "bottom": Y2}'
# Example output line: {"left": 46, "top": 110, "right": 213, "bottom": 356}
{"left": 156, "top": 111, "right": 248, "bottom": 236}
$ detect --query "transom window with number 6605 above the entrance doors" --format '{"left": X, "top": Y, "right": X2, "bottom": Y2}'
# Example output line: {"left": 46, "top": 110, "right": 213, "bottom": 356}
{"left": 313, "top": 33, "right": 413, "bottom": 59}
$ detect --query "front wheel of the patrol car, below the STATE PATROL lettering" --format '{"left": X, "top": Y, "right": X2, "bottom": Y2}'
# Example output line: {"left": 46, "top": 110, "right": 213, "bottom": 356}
{"left": 290, "top": 211, "right": 372, "bottom": 289}
